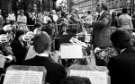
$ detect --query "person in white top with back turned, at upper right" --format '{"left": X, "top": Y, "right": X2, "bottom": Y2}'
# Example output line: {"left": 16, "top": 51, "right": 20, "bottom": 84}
{"left": 119, "top": 8, "right": 133, "bottom": 30}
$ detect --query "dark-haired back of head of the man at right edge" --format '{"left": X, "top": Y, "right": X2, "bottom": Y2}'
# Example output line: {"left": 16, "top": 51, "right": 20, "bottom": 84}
{"left": 111, "top": 30, "right": 131, "bottom": 49}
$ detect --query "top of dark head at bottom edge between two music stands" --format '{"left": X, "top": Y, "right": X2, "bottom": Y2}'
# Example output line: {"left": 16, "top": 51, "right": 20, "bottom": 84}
{"left": 60, "top": 76, "right": 91, "bottom": 84}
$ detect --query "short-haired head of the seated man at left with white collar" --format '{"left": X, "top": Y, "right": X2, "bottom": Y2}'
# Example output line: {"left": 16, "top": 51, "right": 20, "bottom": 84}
{"left": 33, "top": 32, "right": 51, "bottom": 54}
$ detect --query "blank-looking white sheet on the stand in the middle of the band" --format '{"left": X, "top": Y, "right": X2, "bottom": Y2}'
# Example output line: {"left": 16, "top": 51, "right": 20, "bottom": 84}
{"left": 60, "top": 44, "right": 83, "bottom": 59}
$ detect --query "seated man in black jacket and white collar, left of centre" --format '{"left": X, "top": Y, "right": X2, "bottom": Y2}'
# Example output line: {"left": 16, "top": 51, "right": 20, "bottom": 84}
{"left": 24, "top": 32, "right": 66, "bottom": 84}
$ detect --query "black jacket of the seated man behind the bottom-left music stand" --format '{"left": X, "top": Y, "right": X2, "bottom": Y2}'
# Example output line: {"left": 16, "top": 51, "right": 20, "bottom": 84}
{"left": 24, "top": 56, "right": 66, "bottom": 84}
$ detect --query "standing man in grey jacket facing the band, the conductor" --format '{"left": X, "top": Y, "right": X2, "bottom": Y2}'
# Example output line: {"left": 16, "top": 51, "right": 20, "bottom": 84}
{"left": 93, "top": 3, "right": 111, "bottom": 48}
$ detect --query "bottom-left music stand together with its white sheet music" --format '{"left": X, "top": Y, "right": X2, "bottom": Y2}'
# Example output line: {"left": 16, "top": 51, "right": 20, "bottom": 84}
{"left": 3, "top": 65, "right": 47, "bottom": 84}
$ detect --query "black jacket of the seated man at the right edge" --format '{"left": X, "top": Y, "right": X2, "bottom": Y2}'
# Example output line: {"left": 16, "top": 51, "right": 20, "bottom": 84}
{"left": 108, "top": 48, "right": 135, "bottom": 84}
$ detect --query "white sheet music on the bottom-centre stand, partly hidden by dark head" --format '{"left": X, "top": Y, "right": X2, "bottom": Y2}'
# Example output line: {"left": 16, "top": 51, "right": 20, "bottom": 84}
{"left": 70, "top": 70, "right": 109, "bottom": 84}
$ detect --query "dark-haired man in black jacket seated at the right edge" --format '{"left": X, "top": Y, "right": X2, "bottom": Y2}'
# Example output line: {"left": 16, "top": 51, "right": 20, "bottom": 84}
{"left": 108, "top": 30, "right": 135, "bottom": 84}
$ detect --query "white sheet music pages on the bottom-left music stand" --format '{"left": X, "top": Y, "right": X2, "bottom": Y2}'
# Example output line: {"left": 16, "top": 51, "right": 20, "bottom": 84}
{"left": 3, "top": 70, "right": 43, "bottom": 84}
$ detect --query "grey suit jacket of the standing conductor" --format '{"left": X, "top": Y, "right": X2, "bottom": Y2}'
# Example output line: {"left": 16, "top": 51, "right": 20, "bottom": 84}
{"left": 93, "top": 11, "right": 111, "bottom": 47}
